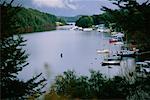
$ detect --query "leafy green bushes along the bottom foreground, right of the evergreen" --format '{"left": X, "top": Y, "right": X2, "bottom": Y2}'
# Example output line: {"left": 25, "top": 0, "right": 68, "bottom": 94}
{"left": 53, "top": 70, "right": 150, "bottom": 100}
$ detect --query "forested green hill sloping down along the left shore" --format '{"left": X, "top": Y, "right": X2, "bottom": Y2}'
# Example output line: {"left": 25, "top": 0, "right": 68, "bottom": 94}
{"left": 15, "top": 7, "right": 65, "bottom": 33}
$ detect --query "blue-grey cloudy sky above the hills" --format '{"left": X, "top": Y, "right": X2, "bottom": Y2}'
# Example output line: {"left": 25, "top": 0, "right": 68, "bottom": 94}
{"left": 1, "top": 0, "right": 146, "bottom": 16}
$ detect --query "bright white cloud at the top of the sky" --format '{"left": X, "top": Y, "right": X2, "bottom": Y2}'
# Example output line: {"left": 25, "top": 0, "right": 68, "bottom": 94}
{"left": 32, "top": 0, "right": 76, "bottom": 9}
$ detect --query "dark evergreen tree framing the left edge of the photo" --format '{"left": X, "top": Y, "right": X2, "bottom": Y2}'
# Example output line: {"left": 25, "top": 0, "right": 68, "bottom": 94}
{"left": 0, "top": 0, "right": 46, "bottom": 99}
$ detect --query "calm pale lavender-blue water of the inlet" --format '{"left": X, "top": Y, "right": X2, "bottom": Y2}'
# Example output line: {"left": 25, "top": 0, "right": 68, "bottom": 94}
{"left": 19, "top": 25, "right": 135, "bottom": 90}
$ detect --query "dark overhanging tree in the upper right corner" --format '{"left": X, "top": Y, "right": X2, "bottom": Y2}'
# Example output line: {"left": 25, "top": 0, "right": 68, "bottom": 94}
{"left": 102, "top": 0, "right": 150, "bottom": 50}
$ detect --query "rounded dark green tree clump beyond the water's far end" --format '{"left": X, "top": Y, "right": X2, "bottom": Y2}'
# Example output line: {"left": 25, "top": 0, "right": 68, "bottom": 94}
{"left": 76, "top": 16, "right": 94, "bottom": 28}
